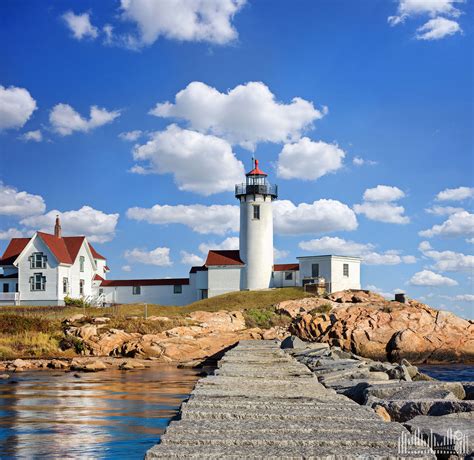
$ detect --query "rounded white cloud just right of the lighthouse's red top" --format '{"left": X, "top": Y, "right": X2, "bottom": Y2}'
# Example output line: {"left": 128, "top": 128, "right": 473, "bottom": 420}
{"left": 277, "top": 137, "right": 346, "bottom": 180}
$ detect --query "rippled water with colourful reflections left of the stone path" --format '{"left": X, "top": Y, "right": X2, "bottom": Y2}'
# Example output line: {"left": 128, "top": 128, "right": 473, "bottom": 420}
{"left": 0, "top": 365, "right": 198, "bottom": 459}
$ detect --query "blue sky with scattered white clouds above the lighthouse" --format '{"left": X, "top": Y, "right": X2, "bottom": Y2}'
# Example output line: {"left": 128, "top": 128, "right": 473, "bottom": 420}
{"left": 0, "top": 0, "right": 474, "bottom": 317}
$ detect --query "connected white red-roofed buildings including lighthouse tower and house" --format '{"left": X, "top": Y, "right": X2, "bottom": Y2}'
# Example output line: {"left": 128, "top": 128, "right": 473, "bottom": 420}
{"left": 0, "top": 160, "right": 360, "bottom": 305}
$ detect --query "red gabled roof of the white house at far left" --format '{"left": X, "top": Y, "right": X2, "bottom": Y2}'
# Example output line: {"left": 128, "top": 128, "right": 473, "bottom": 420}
{"left": 0, "top": 232, "right": 104, "bottom": 266}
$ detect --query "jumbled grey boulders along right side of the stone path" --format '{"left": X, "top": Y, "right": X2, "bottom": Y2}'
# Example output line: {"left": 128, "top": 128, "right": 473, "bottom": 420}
{"left": 281, "top": 336, "right": 474, "bottom": 458}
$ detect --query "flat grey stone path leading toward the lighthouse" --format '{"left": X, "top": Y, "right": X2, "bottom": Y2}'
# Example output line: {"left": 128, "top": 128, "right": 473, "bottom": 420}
{"left": 146, "top": 340, "right": 436, "bottom": 459}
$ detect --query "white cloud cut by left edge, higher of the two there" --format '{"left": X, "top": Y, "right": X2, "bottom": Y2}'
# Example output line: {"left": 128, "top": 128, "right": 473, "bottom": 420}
{"left": 0, "top": 85, "right": 36, "bottom": 131}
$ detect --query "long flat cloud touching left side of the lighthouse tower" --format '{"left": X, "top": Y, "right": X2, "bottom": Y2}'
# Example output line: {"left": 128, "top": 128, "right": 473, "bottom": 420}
{"left": 127, "top": 204, "right": 239, "bottom": 235}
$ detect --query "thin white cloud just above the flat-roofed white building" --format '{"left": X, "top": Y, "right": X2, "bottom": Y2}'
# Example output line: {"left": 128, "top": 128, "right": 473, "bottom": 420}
{"left": 299, "top": 236, "right": 416, "bottom": 265}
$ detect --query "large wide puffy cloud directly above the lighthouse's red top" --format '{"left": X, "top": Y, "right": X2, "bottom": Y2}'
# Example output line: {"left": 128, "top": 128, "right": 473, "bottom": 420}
{"left": 150, "top": 81, "right": 327, "bottom": 150}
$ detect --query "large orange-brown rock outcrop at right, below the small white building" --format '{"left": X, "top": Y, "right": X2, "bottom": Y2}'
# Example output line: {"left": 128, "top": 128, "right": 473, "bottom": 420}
{"left": 290, "top": 291, "right": 474, "bottom": 364}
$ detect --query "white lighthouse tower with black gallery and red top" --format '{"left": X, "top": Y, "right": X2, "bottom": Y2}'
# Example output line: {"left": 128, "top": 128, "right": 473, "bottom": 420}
{"left": 235, "top": 160, "right": 278, "bottom": 290}
